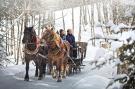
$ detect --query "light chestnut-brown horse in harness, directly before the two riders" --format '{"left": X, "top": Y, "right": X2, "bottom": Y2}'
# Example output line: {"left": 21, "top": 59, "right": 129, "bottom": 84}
{"left": 41, "top": 27, "right": 70, "bottom": 82}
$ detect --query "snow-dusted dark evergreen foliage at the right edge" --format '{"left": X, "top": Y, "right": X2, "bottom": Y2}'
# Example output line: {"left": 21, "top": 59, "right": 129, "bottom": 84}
{"left": 119, "top": 40, "right": 135, "bottom": 89}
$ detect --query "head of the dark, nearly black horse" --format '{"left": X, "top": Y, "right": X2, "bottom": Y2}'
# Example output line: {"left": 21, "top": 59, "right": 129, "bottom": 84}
{"left": 22, "top": 27, "right": 36, "bottom": 44}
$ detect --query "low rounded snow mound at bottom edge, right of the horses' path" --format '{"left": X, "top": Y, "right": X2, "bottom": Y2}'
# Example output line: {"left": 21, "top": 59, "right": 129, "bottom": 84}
{"left": 73, "top": 75, "right": 109, "bottom": 89}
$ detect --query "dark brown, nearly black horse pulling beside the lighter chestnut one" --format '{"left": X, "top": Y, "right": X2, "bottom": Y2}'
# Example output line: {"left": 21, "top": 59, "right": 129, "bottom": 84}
{"left": 22, "top": 27, "right": 47, "bottom": 81}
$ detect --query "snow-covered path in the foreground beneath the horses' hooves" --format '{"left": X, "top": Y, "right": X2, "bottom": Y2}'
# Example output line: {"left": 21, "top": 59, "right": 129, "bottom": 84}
{"left": 0, "top": 62, "right": 116, "bottom": 89}
